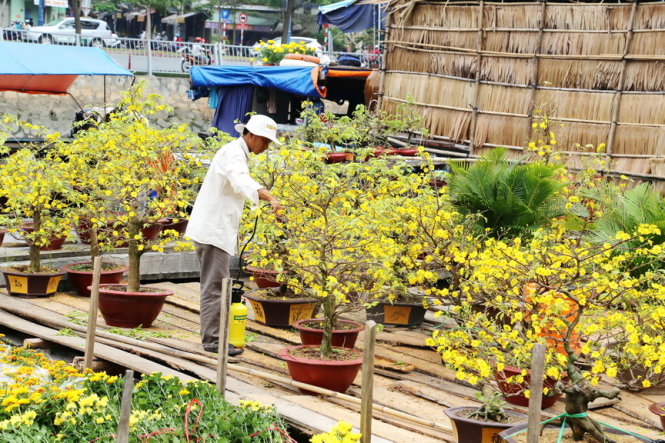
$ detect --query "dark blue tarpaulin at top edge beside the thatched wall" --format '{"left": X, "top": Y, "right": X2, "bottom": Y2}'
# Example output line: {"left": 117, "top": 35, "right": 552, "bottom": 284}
{"left": 317, "top": 0, "right": 386, "bottom": 32}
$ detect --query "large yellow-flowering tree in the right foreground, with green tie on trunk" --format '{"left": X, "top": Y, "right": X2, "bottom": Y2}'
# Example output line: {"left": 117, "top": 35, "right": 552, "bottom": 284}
{"left": 428, "top": 220, "right": 665, "bottom": 441}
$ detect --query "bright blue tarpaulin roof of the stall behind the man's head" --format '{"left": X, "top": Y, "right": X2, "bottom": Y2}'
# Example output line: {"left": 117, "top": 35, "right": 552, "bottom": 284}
{"left": 189, "top": 66, "right": 322, "bottom": 98}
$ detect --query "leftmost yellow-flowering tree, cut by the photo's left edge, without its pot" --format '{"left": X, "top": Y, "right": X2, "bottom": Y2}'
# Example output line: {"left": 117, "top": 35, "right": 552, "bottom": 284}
{"left": 0, "top": 116, "right": 72, "bottom": 273}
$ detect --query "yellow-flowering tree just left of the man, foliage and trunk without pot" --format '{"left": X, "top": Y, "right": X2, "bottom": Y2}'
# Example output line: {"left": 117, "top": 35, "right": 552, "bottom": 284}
{"left": 62, "top": 84, "right": 201, "bottom": 292}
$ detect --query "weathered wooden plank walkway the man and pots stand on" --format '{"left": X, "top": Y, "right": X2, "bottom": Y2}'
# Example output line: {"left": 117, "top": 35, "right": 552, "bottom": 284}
{"left": 0, "top": 282, "right": 665, "bottom": 443}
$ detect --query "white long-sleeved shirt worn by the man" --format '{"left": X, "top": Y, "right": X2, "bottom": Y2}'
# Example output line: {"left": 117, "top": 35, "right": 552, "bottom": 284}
{"left": 185, "top": 137, "right": 263, "bottom": 255}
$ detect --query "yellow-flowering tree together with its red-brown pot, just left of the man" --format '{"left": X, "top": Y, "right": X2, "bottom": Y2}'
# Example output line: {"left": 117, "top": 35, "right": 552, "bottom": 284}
{"left": 63, "top": 84, "right": 198, "bottom": 327}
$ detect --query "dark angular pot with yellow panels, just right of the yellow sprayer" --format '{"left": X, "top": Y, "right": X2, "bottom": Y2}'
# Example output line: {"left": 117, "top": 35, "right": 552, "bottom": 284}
{"left": 244, "top": 292, "right": 319, "bottom": 328}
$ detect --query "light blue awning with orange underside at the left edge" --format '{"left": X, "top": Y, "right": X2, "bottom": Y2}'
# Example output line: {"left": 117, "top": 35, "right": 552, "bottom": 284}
{"left": 0, "top": 41, "right": 133, "bottom": 94}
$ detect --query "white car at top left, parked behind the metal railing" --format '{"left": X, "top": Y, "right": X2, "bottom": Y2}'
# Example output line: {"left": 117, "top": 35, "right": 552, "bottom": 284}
{"left": 23, "top": 17, "right": 114, "bottom": 48}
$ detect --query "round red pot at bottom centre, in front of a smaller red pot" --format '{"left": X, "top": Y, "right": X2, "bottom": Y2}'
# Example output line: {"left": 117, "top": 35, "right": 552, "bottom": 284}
{"left": 279, "top": 346, "right": 363, "bottom": 394}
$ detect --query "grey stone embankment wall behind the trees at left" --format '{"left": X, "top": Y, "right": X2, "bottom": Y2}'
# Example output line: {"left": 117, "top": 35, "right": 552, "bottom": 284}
{"left": 0, "top": 76, "right": 214, "bottom": 138}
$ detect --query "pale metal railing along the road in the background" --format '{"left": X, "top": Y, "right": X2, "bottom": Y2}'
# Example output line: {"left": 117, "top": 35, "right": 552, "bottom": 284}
{"left": 0, "top": 28, "right": 381, "bottom": 74}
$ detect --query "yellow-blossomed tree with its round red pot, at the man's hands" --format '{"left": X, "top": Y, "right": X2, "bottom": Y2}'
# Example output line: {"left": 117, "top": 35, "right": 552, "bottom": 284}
{"left": 264, "top": 141, "right": 408, "bottom": 391}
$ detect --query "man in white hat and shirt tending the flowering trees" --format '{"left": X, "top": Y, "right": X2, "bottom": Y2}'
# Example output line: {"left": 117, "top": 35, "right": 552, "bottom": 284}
{"left": 185, "top": 115, "right": 282, "bottom": 355}
